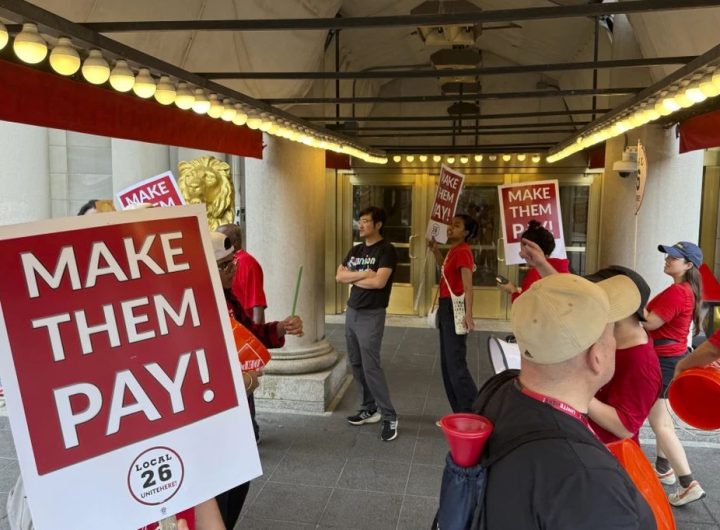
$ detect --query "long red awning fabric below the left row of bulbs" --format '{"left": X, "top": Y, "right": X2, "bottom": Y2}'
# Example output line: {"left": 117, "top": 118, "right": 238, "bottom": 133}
{"left": 0, "top": 60, "right": 262, "bottom": 158}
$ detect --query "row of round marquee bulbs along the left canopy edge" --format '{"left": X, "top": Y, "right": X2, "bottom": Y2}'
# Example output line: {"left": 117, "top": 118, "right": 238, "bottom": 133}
{"left": 0, "top": 22, "right": 387, "bottom": 164}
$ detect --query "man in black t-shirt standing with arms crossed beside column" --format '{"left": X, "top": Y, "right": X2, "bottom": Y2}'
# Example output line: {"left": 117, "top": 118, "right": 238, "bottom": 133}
{"left": 335, "top": 206, "right": 398, "bottom": 442}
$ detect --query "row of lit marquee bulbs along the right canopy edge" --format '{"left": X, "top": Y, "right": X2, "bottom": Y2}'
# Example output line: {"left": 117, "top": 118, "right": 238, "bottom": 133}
{"left": 547, "top": 67, "right": 720, "bottom": 163}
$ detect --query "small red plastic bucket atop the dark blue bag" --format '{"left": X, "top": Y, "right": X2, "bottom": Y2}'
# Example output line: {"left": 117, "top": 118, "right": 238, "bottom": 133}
{"left": 440, "top": 413, "right": 493, "bottom": 467}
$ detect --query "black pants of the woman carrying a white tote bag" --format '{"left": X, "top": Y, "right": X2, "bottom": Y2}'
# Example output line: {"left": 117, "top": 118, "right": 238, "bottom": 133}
{"left": 438, "top": 298, "right": 477, "bottom": 412}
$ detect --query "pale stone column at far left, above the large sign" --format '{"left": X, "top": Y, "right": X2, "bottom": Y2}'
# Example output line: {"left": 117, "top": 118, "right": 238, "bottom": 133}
{"left": 0, "top": 121, "right": 50, "bottom": 225}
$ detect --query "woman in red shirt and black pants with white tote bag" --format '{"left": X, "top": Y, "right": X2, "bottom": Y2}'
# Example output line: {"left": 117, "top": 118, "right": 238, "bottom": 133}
{"left": 428, "top": 215, "right": 478, "bottom": 412}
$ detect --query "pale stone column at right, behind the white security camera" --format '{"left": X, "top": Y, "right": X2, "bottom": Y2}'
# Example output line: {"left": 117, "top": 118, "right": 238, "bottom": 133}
{"left": 599, "top": 124, "right": 703, "bottom": 294}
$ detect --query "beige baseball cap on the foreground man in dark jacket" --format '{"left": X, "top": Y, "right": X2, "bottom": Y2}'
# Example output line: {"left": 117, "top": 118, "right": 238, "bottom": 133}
{"left": 512, "top": 274, "right": 640, "bottom": 364}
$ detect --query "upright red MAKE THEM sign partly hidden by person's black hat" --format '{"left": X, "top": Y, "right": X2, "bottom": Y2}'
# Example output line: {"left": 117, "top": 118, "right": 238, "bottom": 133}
{"left": 498, "top": 180, "right": 565, "bottom": 265}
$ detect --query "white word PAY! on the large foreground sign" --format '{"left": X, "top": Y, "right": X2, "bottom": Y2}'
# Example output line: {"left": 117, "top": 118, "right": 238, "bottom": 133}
{"left": 53, "top": 348, "right": 214, "bottom": 448}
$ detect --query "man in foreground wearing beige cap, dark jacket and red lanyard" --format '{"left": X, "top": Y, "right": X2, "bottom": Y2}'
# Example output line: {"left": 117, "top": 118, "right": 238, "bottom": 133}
{"left": 473, "top": 274, "right": 656, "bottom": 530}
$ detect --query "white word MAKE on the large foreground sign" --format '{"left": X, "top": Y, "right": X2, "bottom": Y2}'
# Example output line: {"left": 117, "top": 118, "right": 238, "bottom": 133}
{"left": 20, "top": 232, "right": 190, "bottom": 298}
